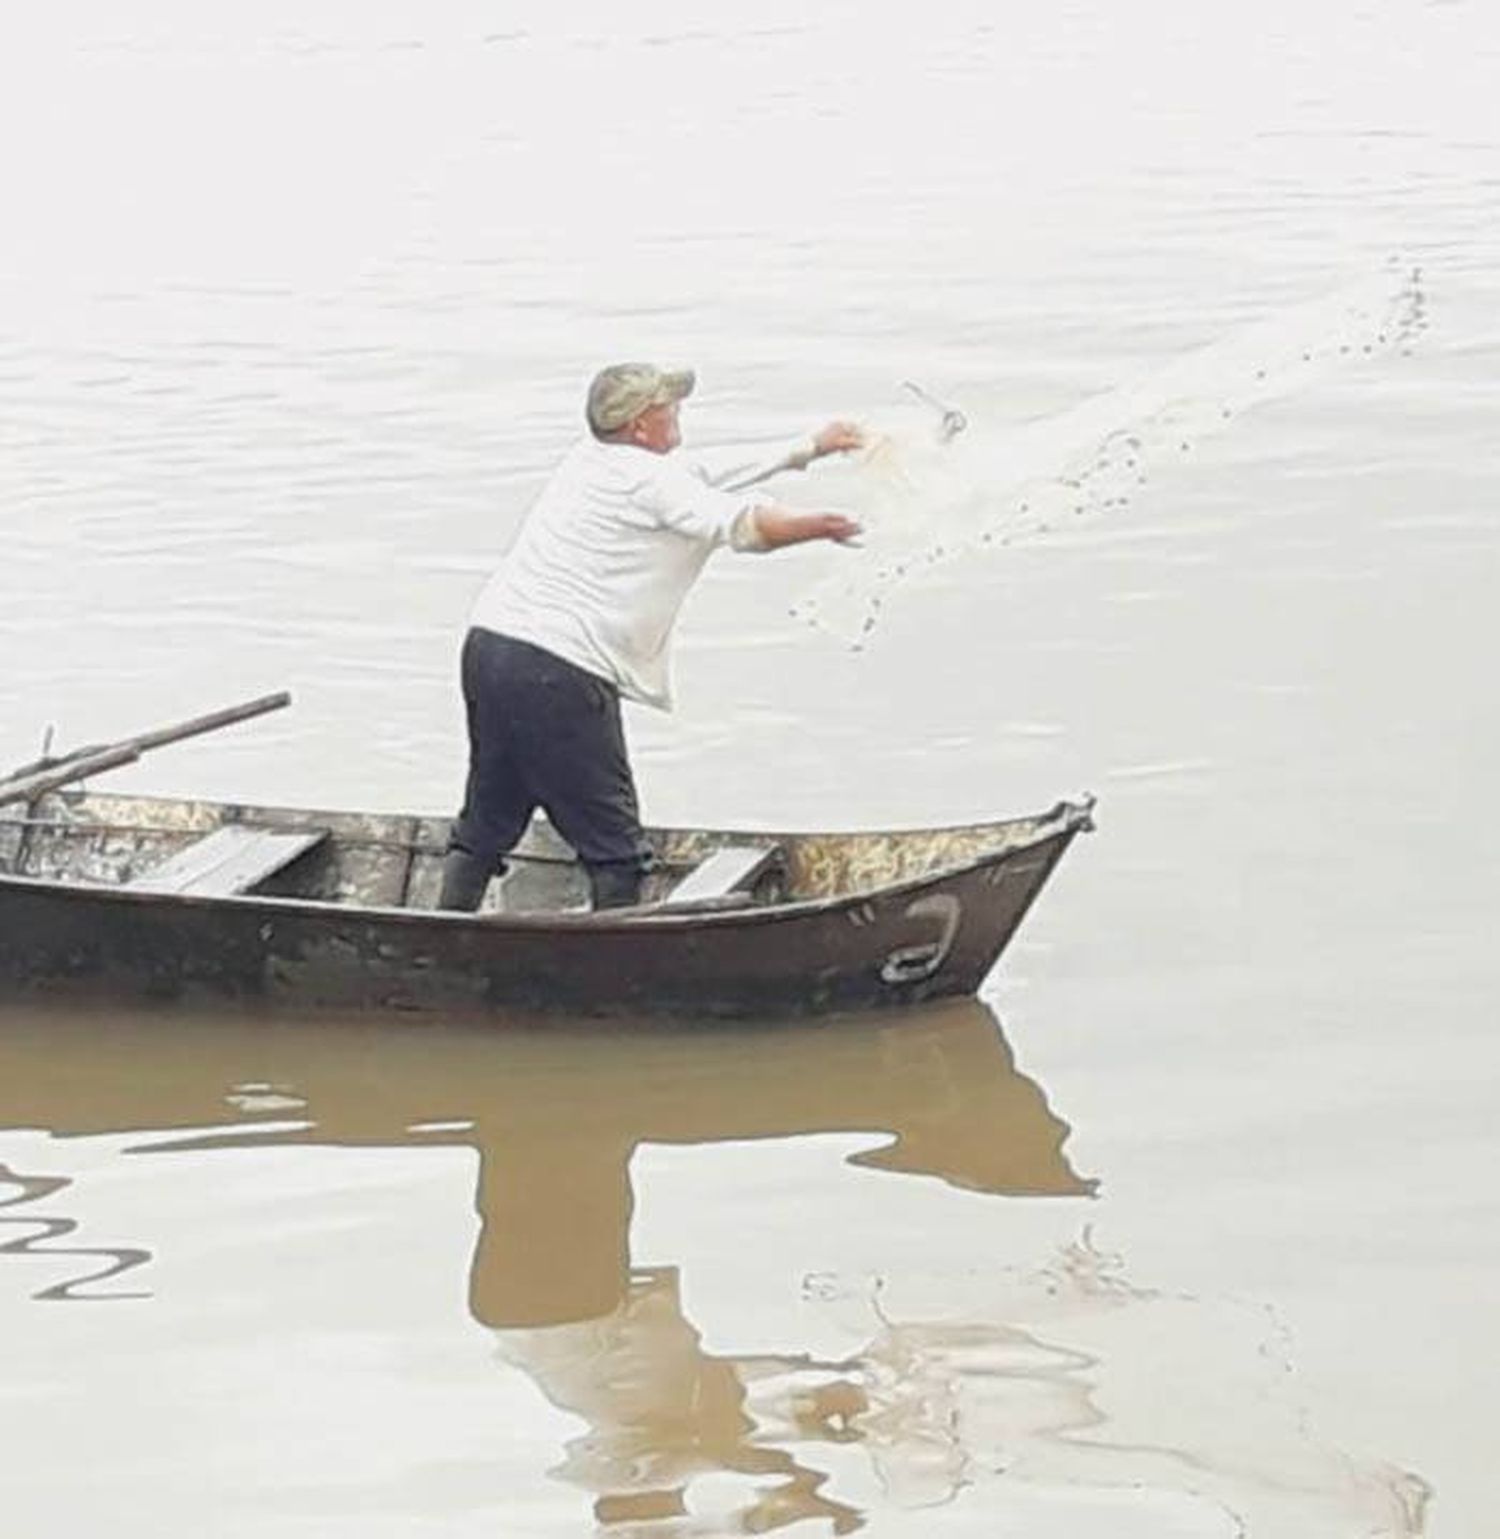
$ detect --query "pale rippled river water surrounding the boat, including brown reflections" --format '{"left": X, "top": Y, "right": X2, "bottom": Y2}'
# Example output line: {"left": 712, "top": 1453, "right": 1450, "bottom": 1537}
{"left": 0, "top": 0, "right": 1500, "bottom": 1539}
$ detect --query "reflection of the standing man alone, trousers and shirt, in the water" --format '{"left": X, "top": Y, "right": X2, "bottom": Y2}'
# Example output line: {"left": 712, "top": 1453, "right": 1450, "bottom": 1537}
{"left": 469, "top": 1133, "right": 858, "bottom": 1533}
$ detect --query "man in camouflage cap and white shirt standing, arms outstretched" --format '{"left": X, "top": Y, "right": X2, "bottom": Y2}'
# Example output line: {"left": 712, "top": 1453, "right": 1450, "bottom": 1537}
{"left": 438, "top": 363, "right": 863, "bottom": 911}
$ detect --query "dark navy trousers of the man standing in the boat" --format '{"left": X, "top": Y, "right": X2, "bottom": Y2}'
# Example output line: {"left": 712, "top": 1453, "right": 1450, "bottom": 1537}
{"left": 449, "top": 626, "right": 651, "bottom": 908}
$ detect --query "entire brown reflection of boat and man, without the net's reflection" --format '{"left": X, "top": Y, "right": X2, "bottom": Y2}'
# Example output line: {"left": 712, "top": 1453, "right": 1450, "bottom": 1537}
{"left": 0, "top": 1002, "right": 1091, "bottom": 1531}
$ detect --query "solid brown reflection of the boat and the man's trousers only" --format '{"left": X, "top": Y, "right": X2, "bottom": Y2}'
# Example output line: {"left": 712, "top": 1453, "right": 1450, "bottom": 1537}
{"left": 0, "top": 1002, "right": 1091, "bottom": 1325}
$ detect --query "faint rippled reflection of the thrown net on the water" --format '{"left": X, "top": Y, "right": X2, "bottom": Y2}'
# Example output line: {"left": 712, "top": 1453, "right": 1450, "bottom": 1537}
{"left": 784, "top": 1230, "right": 1431, "bottom": 1539}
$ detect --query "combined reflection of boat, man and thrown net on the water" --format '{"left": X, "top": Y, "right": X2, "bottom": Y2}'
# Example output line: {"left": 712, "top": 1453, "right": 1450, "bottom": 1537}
{"left": 0, "top": 1003, "right": 1425, "bottom": 1539}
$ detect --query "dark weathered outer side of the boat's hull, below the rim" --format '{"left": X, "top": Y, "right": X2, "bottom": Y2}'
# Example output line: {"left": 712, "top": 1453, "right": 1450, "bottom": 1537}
{"left": 0, "top": 826, "right": 1077, "bottom": 1019}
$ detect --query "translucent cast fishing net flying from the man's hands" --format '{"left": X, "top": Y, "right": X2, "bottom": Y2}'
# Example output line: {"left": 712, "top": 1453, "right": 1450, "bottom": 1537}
{"left": 791, "top": 265, "right": 1426, "bottom": 649}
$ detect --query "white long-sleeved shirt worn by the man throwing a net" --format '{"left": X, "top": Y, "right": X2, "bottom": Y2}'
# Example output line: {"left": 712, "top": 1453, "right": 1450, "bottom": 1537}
{"left": 471, "top": 437, "right": 811, "bottom": 711}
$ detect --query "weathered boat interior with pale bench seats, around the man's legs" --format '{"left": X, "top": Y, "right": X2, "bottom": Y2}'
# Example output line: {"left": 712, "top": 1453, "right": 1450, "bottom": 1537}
{"left": 0, "top": 790, "right": 1063, "bottom": 913}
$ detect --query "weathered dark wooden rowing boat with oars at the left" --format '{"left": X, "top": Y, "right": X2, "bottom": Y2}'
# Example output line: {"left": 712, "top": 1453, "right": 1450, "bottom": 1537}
{"left": 0, "top": 696, "right": 1092, "bottom": 1017}
